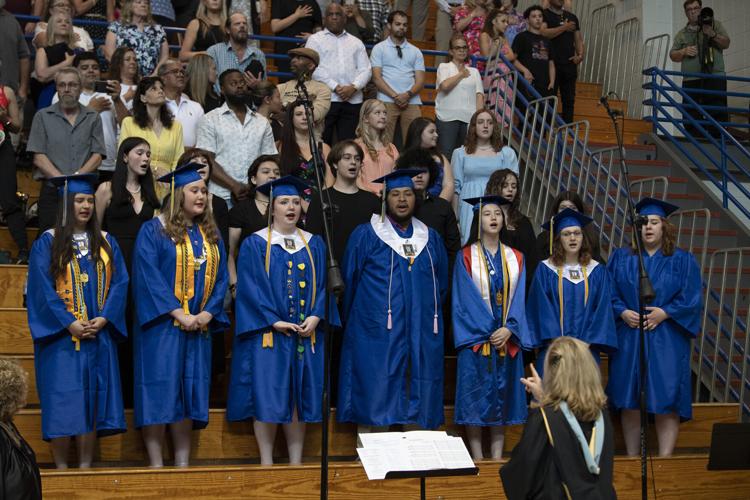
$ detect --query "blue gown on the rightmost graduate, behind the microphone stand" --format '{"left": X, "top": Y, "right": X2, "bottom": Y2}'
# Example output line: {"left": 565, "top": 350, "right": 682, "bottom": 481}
{"left": 607, "top": 248, "right": 703, "bottom": 420}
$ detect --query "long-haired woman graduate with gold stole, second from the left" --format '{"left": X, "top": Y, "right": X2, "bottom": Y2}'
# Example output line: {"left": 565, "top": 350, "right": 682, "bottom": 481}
{"left": 132, "top": 163, "right": 229, "bottom": 467}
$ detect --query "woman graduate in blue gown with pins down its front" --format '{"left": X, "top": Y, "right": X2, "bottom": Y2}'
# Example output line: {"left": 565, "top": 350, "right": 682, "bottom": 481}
{"left": 227, "top": 176, "right": 339, "bottom": 465}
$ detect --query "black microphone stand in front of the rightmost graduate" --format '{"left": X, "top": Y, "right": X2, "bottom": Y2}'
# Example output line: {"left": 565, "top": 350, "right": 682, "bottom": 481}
{"left": 599, "top": 92, "right": 656, "bottom": 500}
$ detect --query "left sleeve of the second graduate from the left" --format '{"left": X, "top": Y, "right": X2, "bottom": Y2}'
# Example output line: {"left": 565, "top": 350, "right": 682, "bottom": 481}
{"left": 132, "top": 219, "right": 181, "bottom": 328}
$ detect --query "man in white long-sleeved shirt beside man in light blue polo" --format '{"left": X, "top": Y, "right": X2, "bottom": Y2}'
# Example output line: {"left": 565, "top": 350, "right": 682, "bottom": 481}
{"left": 305, "top": 3, "right": 372, "bottom": 144}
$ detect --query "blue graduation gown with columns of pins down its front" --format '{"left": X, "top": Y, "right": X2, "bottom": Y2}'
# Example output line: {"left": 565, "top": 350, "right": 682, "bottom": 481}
{"left": 227, "top": 228, "right": 339, "bottom": 424}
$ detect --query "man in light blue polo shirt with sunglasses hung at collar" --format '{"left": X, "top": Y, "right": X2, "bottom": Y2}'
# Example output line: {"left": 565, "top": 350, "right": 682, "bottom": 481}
{"left": 370, "top": 10, "right": 424, "bottom": 146}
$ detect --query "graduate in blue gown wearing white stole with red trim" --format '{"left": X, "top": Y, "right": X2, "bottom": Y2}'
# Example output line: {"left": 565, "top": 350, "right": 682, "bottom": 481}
{"left": 452, "top": 196, "right": 530, "bottom": 460}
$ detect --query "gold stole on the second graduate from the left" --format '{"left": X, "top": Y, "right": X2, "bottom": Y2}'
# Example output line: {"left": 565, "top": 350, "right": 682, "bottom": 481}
{"left": 174, "top": 226, "right": 221, "bottom": 332}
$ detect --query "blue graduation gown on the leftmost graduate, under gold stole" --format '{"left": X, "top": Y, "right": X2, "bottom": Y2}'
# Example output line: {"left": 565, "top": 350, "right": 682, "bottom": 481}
{"left": 26, "top": 230, "right": 128, "bottom": 440}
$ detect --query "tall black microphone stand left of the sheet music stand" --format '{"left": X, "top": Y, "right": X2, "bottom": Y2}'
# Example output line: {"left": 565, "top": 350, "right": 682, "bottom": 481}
{"left": 296, "top": 79, "right": 344, "bottom": 500}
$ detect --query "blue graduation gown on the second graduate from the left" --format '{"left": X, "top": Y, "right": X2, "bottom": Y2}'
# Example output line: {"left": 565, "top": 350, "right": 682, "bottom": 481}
{"left": 132, "top": 218, "right": 229, "bottom": 429}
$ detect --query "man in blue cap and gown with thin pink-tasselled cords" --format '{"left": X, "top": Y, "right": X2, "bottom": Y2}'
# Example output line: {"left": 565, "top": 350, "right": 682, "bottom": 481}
{"left": 336, "top": 169, "right": 448, "bottom": 430}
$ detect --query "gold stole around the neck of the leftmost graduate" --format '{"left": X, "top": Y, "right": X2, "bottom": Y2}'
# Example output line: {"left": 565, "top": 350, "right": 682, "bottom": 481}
{"left": 55, "top": 244, "right": 112, "bottom": 351}
